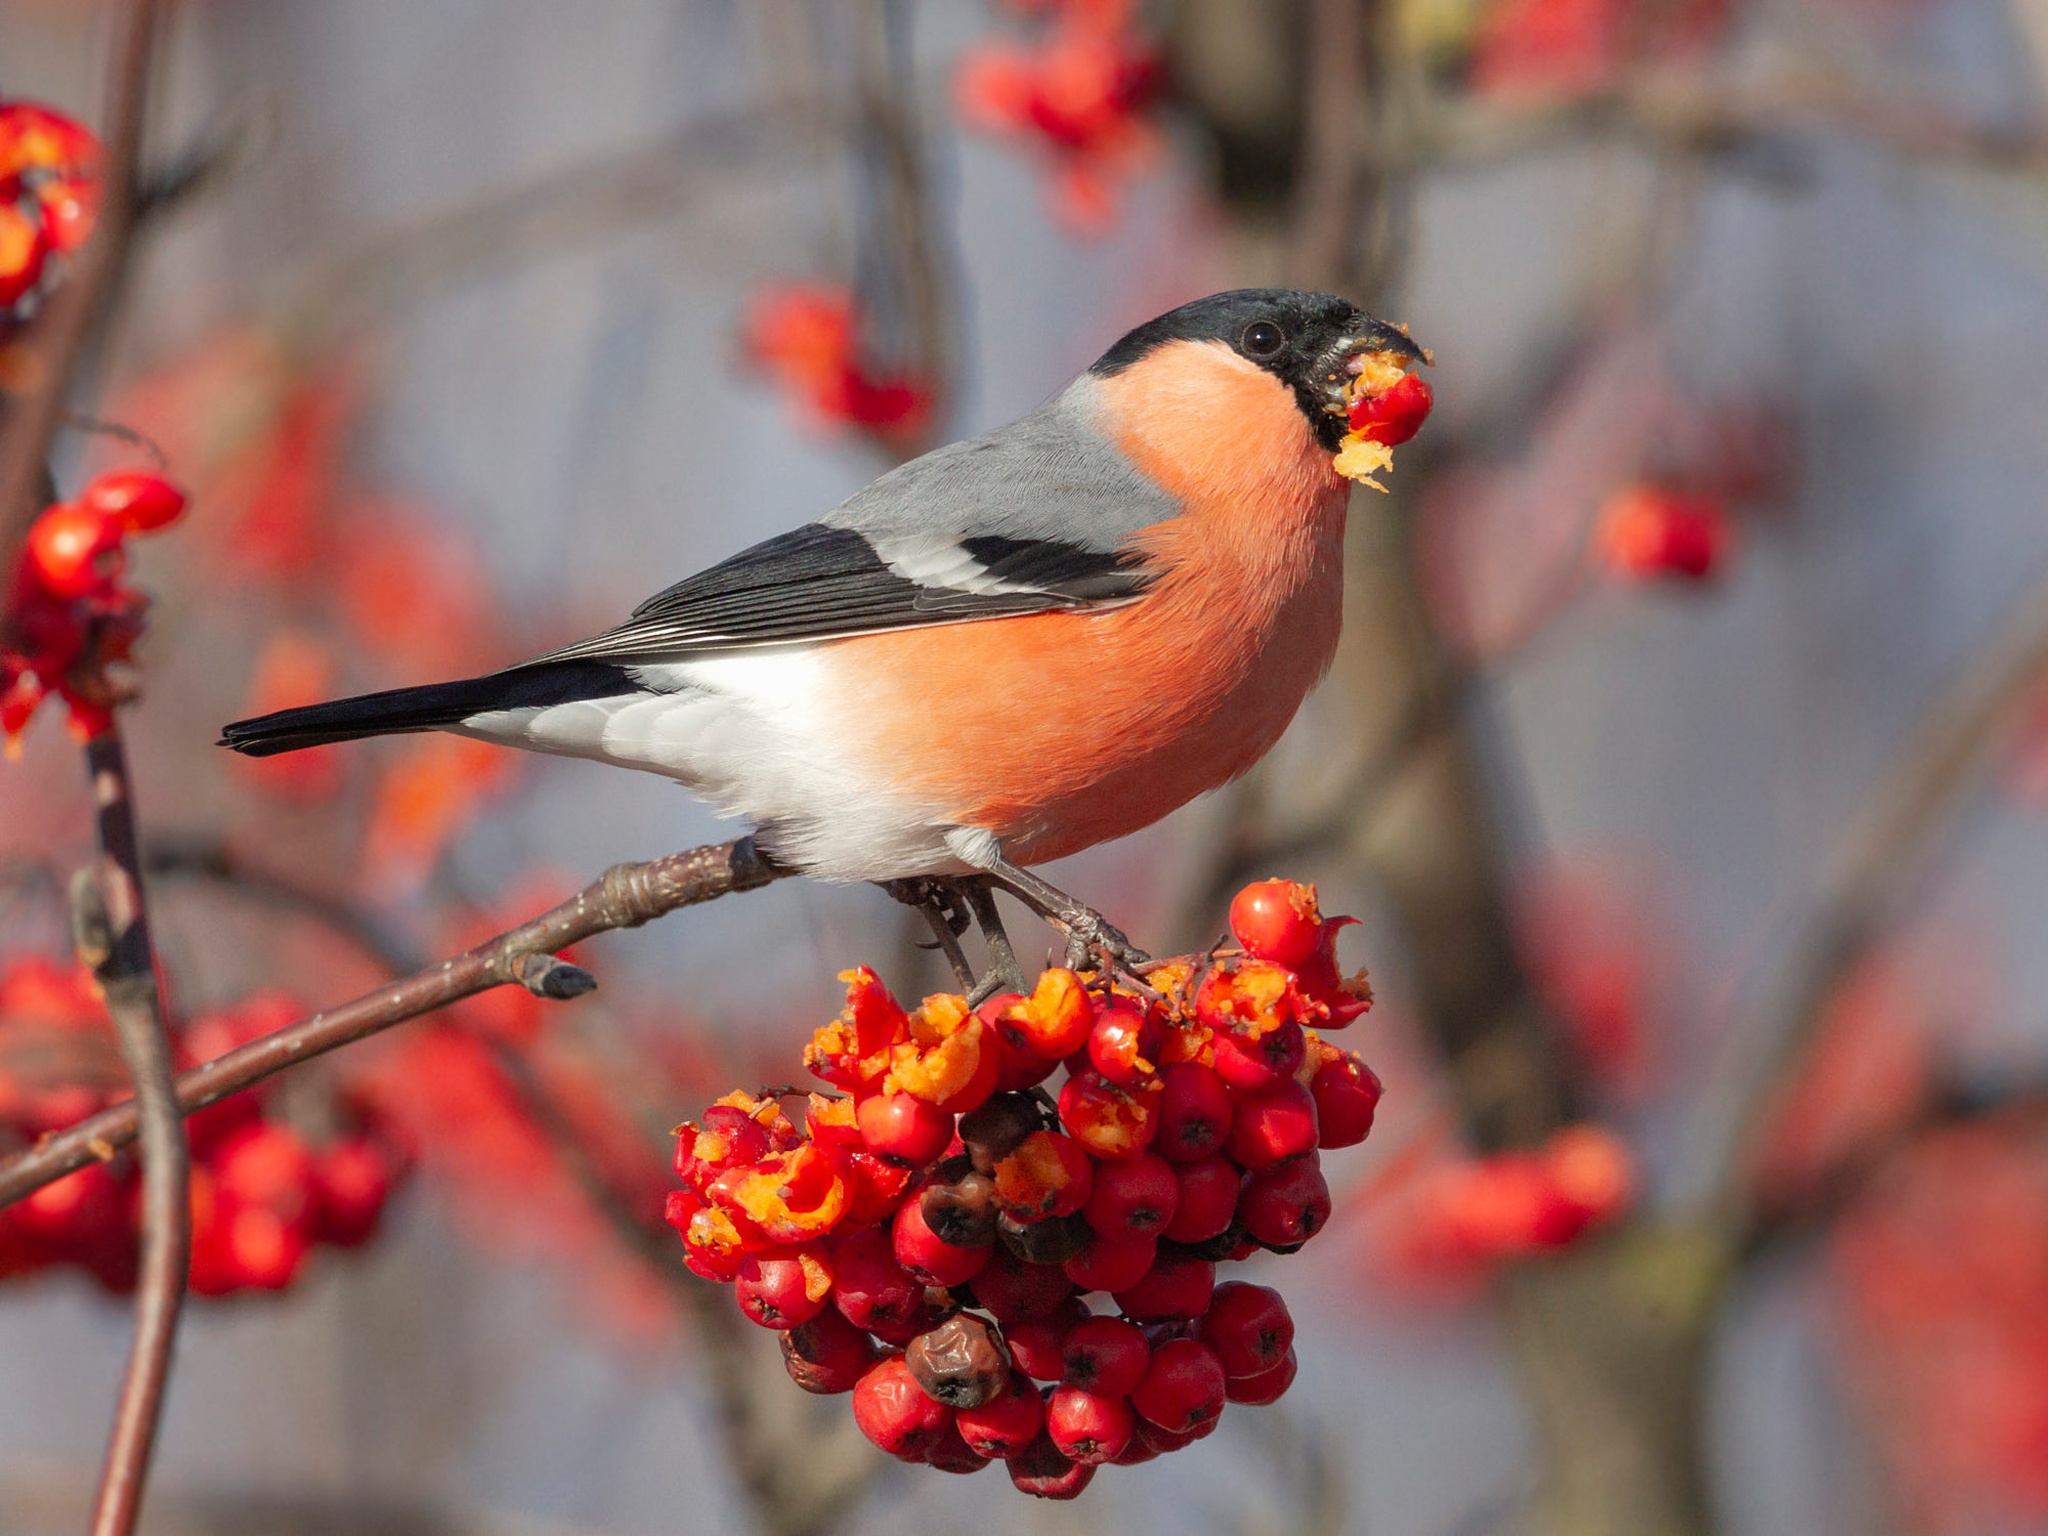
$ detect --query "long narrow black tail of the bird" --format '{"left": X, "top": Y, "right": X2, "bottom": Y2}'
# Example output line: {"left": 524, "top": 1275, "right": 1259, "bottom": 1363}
{"left": 219, "top": 662, "right": 639, "bottom": 758}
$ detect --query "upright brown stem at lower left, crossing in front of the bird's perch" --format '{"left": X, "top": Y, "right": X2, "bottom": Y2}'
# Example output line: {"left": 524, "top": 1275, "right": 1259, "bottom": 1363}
{"left": 72, "top": 725, "right": 193, "bottom": 1536}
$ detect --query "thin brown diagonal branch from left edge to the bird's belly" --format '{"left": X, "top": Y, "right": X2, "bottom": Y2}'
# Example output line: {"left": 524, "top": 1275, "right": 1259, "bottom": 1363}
{"left": 0, "top": 838, "right": 788, "bottom": 1206}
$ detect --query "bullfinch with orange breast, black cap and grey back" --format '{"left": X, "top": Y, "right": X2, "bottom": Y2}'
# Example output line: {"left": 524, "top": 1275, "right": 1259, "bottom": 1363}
{"left": 221, "top": 289, "right": 1421, "bottom": 989}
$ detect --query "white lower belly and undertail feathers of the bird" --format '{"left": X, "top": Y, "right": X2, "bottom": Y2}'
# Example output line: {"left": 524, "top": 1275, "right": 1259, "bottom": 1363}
{"left": 453, "top": 647, "right": 967, "bottom": 881}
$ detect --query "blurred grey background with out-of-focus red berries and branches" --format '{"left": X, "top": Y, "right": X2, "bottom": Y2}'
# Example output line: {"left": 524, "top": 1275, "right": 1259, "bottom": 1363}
{"left": 0, "top": 0, "right": 2048, "bottom": 1536}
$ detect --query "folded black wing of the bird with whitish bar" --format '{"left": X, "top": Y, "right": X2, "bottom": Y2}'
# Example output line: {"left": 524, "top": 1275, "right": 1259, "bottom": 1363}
{"left": 524, "top": 522, "right": 1153, "bottom": 666}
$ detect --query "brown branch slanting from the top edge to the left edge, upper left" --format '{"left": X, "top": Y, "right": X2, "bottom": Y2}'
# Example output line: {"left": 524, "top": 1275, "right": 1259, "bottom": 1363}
{"left": 0, "top": 0, "right": 158, "bottom": 618}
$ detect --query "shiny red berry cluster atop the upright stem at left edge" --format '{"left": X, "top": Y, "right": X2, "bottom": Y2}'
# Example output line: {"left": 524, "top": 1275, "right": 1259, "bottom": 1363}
{"left": 0, "top": 469, "right": 184, "bottom": 748}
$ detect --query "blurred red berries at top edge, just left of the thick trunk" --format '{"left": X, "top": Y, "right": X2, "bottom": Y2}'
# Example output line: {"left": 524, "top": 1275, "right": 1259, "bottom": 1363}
{"left": 956, "top": 0, "right": 1163, "bottom": 231}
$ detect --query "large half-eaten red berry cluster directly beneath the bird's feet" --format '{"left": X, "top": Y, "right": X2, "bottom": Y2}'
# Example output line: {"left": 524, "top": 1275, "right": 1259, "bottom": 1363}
{"left": 668, "top": 881, "right": 1380, "bottom": 1497}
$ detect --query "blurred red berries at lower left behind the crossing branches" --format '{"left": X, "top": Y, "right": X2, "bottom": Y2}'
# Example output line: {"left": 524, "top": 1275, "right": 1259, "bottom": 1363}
{"left": 0, "top": 958, "right": 410, "bottom": 1296}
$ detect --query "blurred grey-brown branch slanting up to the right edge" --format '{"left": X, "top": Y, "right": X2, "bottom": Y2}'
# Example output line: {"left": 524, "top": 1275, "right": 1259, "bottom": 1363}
{"left": 1702, "top": 565, "right": 2048, "bottom": 1231}
